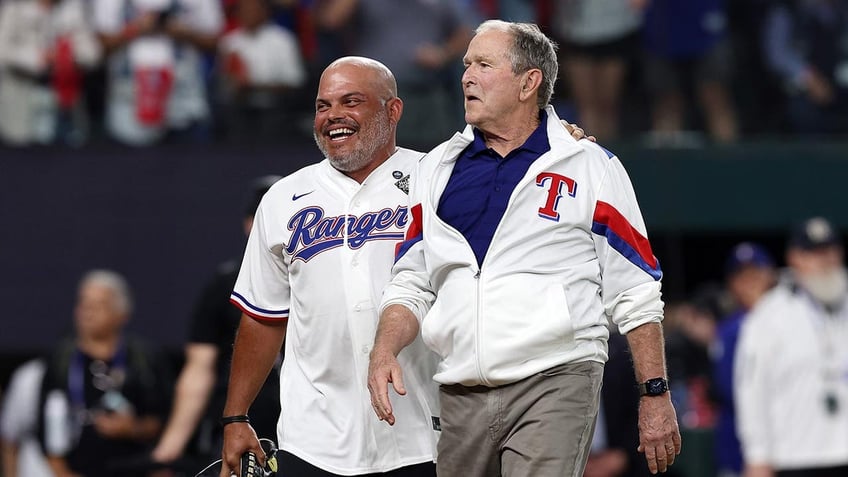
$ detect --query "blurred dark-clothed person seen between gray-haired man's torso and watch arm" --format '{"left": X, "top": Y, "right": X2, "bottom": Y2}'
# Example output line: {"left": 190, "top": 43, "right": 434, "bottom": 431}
{"left": 583, "top": 327, "right": 650, "bottom": 477}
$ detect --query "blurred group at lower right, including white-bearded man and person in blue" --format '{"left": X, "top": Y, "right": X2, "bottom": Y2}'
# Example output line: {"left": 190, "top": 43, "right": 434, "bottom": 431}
{"left": 664, "top": 217, "right": 848, "bottom": 477}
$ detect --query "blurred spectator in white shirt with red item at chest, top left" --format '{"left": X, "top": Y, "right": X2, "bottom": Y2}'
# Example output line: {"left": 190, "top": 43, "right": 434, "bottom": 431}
{"left": 92, "top": 0, "right": 223, "bottom": 145}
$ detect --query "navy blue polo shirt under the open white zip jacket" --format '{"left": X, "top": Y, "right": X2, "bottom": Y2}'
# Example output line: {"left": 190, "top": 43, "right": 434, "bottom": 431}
{"left": 436, "top": 111, "right": 551, "bottom": 266}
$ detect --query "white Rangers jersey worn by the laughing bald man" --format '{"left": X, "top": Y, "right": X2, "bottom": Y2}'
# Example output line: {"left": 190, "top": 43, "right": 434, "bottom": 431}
{"left": 232, "top": 149, "right": 438, "bottom": 475}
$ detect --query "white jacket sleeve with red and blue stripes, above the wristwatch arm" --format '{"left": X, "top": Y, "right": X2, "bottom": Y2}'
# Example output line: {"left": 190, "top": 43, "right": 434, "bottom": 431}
{"left": 592, "top": 148, "right": 663, "bottom": 334}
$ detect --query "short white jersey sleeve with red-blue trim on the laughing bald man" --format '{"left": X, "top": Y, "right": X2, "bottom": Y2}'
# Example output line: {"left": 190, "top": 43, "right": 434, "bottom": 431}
{"left": 230, "top": 195, "right": 291, "bottom": 320}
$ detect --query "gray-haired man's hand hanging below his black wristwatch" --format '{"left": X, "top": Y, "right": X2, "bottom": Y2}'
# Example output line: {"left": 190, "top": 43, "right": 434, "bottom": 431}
{"left": 638, "top": 393, "right": 681, "bottom": 474}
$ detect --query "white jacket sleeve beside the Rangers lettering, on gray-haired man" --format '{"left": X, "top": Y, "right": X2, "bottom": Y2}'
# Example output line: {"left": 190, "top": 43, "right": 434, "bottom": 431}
{"left": 380, "top": 156, "right": 436, "bottom": 323}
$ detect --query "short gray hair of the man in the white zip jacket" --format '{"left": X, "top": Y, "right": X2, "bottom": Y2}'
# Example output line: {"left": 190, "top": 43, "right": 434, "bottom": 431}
{"left": 474, "top": 20, "right": 559, "bottom": 109}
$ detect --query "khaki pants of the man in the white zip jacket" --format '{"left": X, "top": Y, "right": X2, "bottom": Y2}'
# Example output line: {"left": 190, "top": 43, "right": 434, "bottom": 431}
{"left": 437, "top": 362, "right": 604, "bottom": 477}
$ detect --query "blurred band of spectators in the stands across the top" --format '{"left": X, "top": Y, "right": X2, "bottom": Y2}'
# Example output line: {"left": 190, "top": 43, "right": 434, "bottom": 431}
{"left": 0, "top": 0, "right": 848, "bottom": 147}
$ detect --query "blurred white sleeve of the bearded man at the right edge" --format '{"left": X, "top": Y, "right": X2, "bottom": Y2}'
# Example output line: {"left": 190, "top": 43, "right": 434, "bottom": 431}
{"left": 733, "top": 308, "right": 774, "bottom": 464}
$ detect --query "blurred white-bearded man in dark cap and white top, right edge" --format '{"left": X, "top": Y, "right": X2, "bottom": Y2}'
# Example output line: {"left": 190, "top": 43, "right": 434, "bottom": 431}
{"left": 734, "top": 217, "right": 848, "bottom": 477}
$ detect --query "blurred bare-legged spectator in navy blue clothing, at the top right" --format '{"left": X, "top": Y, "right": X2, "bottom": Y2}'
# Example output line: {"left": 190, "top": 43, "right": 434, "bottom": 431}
{"left": 644, "top": 0, "right": 737, "bottom": 145}
